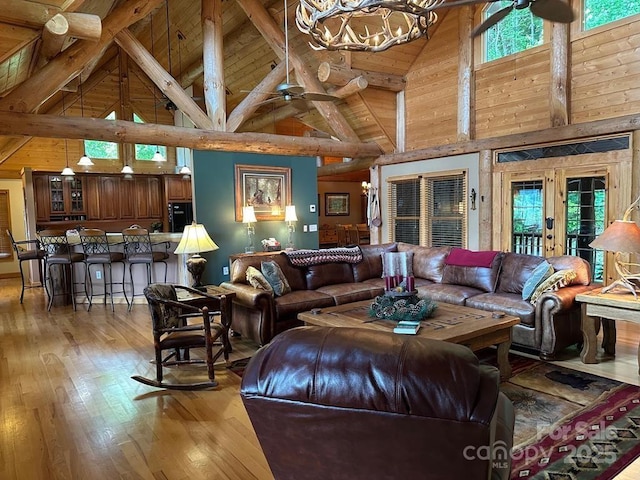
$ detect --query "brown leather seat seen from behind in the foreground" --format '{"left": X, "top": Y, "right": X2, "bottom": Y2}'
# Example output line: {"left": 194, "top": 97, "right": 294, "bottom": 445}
{"left": 240, "top": 327, "right": 515, "bottom": 480}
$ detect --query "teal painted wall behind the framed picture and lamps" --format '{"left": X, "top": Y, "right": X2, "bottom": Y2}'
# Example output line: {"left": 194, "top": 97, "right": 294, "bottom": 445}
{"left": 192, "top": 151, "right": 318, "bottom": 285}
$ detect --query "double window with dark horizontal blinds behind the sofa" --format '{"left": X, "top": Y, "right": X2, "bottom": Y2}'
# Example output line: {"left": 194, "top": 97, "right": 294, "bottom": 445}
{"left": 388, "top": 172, "right": 467, "bottom": 247}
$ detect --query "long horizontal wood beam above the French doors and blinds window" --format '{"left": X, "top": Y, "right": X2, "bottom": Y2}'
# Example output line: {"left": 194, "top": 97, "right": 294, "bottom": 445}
{"left": 375, "top": 115, "right": 640, "bottom": 165}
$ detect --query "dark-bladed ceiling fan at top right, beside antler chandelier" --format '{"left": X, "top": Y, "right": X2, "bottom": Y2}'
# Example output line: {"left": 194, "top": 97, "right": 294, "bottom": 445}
{"left": 439, "top": 0, "right": 576, "bottom": 37}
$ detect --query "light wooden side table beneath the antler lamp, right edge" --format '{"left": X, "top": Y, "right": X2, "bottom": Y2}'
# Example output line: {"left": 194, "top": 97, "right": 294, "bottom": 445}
{"left": 576, "top": 289, "right": 640, "bottom": 374}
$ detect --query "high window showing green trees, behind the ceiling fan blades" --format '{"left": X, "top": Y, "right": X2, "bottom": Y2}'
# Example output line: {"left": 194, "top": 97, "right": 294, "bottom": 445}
{"left": 482, "top": 1, "right": 543, "bottom": 62}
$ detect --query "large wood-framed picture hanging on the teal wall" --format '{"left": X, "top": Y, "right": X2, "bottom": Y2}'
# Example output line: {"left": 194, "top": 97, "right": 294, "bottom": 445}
{"left": 235, "top": 165, "right": 291, "bottom": 222}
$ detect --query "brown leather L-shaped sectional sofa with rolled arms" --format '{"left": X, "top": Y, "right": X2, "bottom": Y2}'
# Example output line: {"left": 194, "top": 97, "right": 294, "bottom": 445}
{"left": 221, "top": 242, "right": 593, "bottom": 360}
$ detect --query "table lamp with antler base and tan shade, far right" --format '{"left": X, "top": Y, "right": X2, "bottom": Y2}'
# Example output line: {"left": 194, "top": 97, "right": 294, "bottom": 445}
{"left": 589, "top": 197, "right": 640, "bottom": 298}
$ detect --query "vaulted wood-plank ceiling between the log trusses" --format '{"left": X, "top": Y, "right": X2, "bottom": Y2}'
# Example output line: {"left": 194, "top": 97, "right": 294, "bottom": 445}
{"left": 0, "top": 0, "right": 456, "bottom": 181}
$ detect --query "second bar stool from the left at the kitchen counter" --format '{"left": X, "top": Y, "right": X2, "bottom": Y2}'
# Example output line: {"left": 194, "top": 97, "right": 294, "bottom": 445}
{"left": 38, "top": 229, "right": 87, "bottom": 311}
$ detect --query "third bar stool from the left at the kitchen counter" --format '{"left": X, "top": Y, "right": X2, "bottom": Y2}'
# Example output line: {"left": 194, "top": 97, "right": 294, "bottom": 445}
{"left": 78, "top": 228, "right": 129, "bottom": 311}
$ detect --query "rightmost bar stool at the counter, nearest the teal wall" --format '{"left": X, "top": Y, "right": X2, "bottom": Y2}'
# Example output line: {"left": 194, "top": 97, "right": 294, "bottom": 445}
{"left": 122, "top": 225, "right": 169, "bottom": 311}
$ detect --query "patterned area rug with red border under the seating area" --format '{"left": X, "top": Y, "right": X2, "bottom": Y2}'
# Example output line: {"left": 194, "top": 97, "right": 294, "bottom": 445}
{"left": 228, "top": 350, "right": 640, "bottom": 480}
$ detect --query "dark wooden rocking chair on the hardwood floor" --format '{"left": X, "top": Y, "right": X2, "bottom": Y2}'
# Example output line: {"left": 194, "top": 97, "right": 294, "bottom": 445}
{"left": 131, "top": 283, "right": 230, "bottom": 390}
